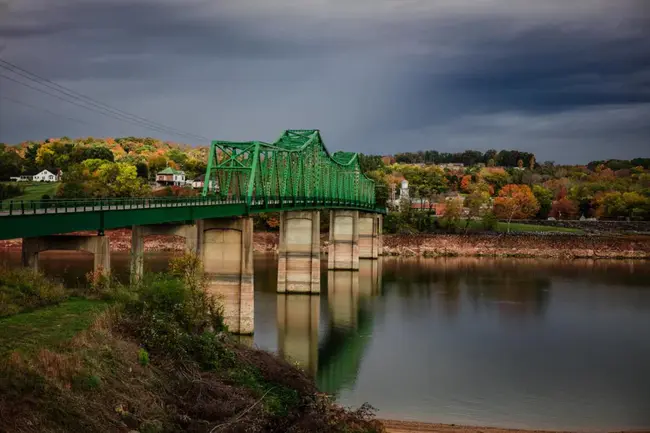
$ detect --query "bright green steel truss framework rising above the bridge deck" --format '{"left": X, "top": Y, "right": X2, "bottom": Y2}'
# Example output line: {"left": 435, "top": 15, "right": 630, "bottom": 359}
{"left": 203, "top": 130, "right": 375, "bottom": 207}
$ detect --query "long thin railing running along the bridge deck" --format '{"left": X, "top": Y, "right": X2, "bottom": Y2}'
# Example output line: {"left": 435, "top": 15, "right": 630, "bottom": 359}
{"left": 0, "top": 196, "right": 382, "bottom": 217}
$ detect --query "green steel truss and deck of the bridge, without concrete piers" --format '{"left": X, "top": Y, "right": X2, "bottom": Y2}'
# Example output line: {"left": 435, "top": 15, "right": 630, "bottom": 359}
{"left": 0, "top": 130, "right": 383, "bottom": 240}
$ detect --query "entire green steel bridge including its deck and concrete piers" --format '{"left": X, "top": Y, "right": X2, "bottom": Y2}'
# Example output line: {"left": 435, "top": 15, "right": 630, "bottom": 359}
{"left": 0, "top": 130, "right": 385, "bottom": 334}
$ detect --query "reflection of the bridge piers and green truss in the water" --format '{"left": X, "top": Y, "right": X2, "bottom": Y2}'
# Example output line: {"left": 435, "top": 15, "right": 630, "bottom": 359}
{"left": 276, "top": 260, "right": 381, "bottom": 395}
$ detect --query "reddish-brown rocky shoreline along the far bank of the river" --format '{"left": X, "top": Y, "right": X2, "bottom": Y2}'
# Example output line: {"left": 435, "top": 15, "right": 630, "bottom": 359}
{"left": 0, "top": 229, "right": 650, "bottom": 259}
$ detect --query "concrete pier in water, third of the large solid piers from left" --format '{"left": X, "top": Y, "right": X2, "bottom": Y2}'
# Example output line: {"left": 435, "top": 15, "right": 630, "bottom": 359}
{"left": 327, "top": 210, "right": 359, "bottom": 271}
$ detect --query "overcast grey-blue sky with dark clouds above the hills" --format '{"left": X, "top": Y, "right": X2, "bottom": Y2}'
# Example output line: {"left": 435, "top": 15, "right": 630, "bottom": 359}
{"left": 0, "top": 0, "right": 650, "bottom": 163}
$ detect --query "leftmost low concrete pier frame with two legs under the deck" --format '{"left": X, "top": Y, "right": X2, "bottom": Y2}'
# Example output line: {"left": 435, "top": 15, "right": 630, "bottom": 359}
{"left": 22, "top": 235, "right": 111, "bottom": 273}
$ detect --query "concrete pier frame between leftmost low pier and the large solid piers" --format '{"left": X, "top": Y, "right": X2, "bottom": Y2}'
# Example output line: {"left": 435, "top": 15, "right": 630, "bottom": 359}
{"left": 131, "top": 220, "right": 203, "bottom": 283}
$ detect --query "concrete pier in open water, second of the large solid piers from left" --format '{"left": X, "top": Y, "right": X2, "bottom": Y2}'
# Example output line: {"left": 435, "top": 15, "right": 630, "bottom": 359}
{"left": 278, "top": 211, "right": 320, "bottom": 293}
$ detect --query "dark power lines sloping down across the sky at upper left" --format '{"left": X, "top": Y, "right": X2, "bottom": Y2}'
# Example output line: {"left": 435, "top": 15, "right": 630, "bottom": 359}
{"left": 0, "top": 59, "right": 209, "bottom": 141}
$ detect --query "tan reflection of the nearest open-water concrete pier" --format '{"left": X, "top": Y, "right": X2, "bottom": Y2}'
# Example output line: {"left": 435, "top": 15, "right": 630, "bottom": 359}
{"left": 277, "top": 294, "right": 320, "bottom": 377}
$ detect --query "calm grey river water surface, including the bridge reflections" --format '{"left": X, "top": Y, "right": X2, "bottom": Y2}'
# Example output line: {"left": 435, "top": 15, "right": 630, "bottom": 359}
{"left": 0, "top": 253, "right": 650, "bottom": 430}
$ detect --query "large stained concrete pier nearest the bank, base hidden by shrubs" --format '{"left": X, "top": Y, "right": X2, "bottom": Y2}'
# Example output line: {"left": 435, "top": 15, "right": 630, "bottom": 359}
{"left": 202, "top": 218, "right": 254, "bottom": 334}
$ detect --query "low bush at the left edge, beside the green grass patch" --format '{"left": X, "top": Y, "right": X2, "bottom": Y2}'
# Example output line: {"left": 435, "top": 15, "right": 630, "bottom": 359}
{"left": 0, "top": 267, "right": 66, "bottom": 317}
